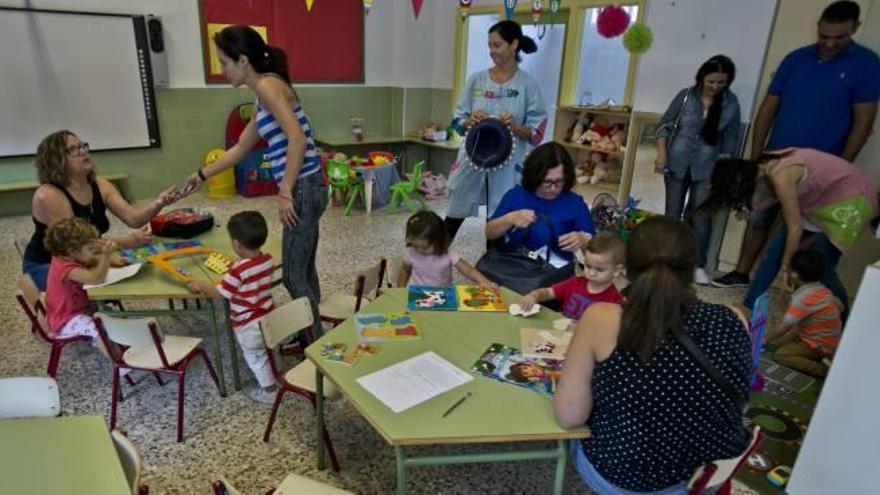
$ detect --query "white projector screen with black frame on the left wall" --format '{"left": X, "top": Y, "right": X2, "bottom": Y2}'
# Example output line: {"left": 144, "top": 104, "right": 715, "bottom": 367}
{"left": 0, "top": 8, "right": 160, "bottom": 156}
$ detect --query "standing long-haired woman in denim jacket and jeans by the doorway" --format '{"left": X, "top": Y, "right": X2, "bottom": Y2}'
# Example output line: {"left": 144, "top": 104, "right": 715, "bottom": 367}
{"left": 654, "top": 55, "right": 740, "bottom": 285}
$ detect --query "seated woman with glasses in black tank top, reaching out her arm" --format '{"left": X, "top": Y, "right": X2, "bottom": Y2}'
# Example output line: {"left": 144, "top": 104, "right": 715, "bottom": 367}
{"left": 22, "top": 130, "right": 176, "bottom": 290}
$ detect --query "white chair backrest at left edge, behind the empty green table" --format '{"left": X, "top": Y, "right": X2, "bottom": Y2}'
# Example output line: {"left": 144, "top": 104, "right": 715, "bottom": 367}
{"left": 0, "top": 376, "right": 61, "bottom": 419}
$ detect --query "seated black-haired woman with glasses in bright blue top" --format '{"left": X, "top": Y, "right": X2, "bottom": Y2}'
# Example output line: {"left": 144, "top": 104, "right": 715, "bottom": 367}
{"left": 486, "top": 142, "right": 596, "bottom": 263}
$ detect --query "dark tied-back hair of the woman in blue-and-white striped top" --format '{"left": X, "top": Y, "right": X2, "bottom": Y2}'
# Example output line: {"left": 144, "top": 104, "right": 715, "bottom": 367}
{"left": 214, "top": 26, "right": 290, "bottom": 84}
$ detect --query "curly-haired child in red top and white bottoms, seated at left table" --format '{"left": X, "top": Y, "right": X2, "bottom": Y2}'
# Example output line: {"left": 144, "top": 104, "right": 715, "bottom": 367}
{"left": 43, "top": 217, "right": 116, "bottom": 344}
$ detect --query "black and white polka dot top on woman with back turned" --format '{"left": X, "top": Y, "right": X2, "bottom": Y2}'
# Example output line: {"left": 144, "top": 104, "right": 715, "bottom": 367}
{"left": 583, "top": 303, "right": 751, "bottom": 492}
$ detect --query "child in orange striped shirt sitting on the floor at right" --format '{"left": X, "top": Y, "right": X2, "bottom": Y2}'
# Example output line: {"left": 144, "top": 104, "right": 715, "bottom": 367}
{"left": 764, "top": 251, "right": 842, "bottom": 378}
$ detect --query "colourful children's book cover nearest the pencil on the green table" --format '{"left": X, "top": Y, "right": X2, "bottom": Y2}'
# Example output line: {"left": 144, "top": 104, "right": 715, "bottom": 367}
{"left": 471, "top": 343, "right": 563, "bottom": 397}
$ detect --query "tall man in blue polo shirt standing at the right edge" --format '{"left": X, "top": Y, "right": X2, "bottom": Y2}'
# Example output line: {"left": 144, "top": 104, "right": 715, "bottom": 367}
{"left": 712, "top": 0, "right": 880, "bottom": 287}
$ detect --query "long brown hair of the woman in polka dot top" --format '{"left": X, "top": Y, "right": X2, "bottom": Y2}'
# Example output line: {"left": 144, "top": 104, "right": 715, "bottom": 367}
{"left": 617, "top": 215, "right": 697, "bottom": 364}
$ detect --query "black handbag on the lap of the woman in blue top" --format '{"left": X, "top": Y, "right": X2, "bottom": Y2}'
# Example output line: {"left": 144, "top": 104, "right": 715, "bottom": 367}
{"left": 476, "top": 215, "right": 575, "bottom": 295}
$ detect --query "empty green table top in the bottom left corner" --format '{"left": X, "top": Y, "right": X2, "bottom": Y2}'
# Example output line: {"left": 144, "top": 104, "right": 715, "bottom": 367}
{"left": 0, "top": 416, "right": 131, "bottom": 495}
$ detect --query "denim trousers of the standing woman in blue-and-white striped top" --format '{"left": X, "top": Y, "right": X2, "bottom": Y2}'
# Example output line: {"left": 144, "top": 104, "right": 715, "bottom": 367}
{"left": 281, "top": 172, "right": 328, "bottom": 338}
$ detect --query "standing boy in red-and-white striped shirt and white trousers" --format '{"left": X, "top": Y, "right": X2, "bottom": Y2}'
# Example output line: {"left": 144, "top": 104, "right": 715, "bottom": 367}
{"left": 188, "top": 211, "right": 277, "bottom": 404}
